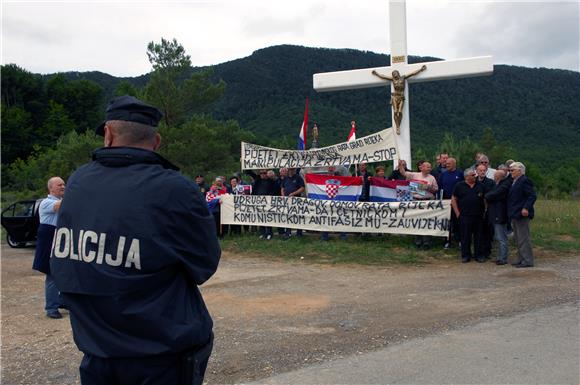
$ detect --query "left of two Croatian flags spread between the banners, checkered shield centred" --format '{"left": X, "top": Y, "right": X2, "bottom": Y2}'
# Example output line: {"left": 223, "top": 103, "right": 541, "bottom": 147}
{"left": 306, "top": 174, "right": 363, "bottom": 201}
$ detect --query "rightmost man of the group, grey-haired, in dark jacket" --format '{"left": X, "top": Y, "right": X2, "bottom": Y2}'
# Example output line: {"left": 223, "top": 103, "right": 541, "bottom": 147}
{"left": 508, "top": 162, "right": 536, "bottom": 267}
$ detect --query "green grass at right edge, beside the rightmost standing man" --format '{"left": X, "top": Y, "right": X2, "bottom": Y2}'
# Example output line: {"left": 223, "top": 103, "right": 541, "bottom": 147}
{"left": 531, "top": 200, "right": 580, "bottom": 251}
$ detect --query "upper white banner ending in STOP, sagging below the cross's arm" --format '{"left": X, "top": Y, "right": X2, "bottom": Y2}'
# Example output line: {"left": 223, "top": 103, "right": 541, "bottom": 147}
{"left": 241, "top": 128, "right": 399, "bottom": 170}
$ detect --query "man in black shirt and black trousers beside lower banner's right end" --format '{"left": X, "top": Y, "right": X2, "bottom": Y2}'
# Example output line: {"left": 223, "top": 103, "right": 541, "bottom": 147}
{"left": 451, "top": 168, "right": 485, "bottom": 263}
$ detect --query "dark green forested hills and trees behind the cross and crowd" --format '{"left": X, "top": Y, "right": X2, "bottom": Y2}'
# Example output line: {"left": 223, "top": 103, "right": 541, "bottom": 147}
{"left": 1, "top": 43, "right": 580, "bottom": 195}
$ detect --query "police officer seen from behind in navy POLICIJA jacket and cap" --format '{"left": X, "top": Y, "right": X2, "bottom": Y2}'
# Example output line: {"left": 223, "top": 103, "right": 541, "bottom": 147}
{"left": 51, "top": 96, "right": 221, "bottom": 385}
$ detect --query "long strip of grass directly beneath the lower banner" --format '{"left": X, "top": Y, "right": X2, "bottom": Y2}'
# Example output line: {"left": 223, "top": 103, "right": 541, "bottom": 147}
{"left": 222, "top": 229, "right": 458, "bottom": 265}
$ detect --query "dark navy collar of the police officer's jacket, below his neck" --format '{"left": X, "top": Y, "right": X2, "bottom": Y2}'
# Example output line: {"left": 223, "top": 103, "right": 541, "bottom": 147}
{"left": 93, "top": 147, "right": 179, "bottom": 171}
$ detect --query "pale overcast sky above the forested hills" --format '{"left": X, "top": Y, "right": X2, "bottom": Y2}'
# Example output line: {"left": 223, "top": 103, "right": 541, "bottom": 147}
{"left": 2, "top": 0, "right": 580, "bottom": 76}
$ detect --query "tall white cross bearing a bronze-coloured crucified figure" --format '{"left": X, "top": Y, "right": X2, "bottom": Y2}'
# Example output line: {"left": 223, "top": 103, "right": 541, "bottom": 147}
{"left": 313, "top": 0, "right": 493, "bottom": 168}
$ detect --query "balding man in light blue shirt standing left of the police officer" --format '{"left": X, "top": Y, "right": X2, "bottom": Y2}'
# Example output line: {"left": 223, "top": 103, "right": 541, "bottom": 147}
{"left": 32, "top": 176, "right": 65, "bottom": 319}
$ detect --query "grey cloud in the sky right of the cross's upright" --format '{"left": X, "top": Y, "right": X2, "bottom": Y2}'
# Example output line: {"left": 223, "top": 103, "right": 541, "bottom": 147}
{"left": 452, "top": 2, "right": 580, "bottom": 70}
